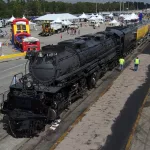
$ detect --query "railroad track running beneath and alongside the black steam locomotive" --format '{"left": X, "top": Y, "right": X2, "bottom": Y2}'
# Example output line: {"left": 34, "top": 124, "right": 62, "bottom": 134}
{"left": 0, "top": 39, "right": 148, "bottom": 150}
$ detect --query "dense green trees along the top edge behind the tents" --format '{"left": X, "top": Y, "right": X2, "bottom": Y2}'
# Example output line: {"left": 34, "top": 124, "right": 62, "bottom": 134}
{"left": 0, "top": 0, "right": 150, "bottom": 18}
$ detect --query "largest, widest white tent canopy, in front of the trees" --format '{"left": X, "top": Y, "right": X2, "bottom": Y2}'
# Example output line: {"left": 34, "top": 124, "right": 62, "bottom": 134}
{"left": 35, "top": 13, "right": 78, "bottom": 21}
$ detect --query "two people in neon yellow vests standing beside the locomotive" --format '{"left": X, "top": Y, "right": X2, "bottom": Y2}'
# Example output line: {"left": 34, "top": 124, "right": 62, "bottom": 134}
{"left": 119, "top": 57, "right": 140, "bottom": 71}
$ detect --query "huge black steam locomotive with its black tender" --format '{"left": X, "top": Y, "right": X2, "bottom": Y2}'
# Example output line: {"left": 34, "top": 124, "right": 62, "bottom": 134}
{"left": 2, "top": 27, "right": 136, "bottom": 136}
